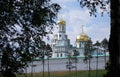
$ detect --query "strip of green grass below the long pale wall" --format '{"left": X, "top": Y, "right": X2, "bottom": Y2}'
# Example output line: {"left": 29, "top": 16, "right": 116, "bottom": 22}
{"left": 17, "top": 70, "right": 106, "bottom": 77}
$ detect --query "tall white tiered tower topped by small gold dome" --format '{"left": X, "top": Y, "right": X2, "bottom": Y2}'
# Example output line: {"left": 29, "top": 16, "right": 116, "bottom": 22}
{"left": 52, "top": 19, "right": 70, "bottom": 58}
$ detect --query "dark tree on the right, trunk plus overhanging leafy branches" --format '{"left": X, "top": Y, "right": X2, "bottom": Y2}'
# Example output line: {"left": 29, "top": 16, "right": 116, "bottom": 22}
{"left": 79, "top": 0, "right": 120, "bottom": 77}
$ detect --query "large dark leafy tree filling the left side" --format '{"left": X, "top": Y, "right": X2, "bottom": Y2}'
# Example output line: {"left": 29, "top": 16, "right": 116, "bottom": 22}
{"left": 0, "top": 0, "right": 60, "bottom": 77}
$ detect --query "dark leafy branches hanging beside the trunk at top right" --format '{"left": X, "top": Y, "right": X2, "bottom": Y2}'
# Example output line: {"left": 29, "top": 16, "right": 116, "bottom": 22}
{"left": 78, "top": 0, "right": 110, "bottom": 17}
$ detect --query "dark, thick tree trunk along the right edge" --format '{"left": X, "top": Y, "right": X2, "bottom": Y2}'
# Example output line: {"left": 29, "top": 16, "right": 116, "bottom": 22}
{"left": 107, "top": 0, "right": 120, "bottom": 77}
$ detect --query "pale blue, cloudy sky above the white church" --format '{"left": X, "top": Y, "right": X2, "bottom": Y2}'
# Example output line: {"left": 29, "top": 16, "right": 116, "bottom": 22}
{"left": 49, "top": 0, "right": 110, "bottom": 45}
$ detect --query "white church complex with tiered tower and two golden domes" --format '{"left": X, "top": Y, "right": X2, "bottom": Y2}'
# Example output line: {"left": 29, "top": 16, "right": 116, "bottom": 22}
{"left": 51, "top": 19, "right": 91, "bottom": 58}
